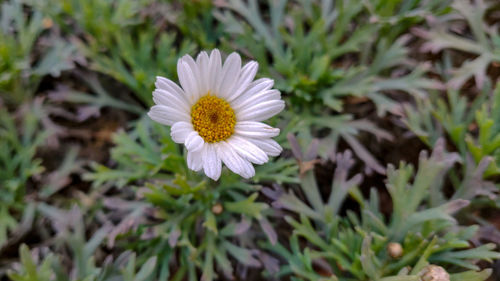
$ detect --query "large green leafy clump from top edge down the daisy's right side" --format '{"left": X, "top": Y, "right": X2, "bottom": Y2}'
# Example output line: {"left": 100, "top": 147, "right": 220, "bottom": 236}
{"left": 215, "top": 0, "right": 446, "bottom": 174}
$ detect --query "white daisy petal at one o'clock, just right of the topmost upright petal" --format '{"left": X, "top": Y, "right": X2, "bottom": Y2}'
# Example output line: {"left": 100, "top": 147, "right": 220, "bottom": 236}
{"left": 215, "top": 53, "right": 241, "bottom": 99}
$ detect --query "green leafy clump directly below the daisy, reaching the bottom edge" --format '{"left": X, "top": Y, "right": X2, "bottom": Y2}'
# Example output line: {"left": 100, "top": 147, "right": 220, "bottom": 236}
{"left": 136, "top": 178, "right": 269, "bottom": 280}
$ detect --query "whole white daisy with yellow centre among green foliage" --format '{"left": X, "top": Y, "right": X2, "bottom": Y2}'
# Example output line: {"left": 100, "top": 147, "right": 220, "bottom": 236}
{"left": 148, "top": 50, "right": 285, "bottom": 180}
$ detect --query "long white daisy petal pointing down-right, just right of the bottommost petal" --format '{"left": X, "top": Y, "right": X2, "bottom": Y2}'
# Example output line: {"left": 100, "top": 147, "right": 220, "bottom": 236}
{"left": 216, "top": 141, "right": 255, "bottom": 179}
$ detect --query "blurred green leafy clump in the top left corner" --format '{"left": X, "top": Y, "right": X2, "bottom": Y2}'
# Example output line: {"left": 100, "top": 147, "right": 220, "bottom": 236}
{"left": 0, "top": 0, "right": 76, "bottom": 106}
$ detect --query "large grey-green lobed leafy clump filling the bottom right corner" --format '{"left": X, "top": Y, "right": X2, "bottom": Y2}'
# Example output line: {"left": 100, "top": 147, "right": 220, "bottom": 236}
{"left": 268, "top": 137, "right": 500, "bottom": 281}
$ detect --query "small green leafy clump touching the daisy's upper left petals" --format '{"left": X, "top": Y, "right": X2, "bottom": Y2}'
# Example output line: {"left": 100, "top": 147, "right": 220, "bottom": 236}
{"left": 80, "top": 27, "right": 194, "bottom": 106}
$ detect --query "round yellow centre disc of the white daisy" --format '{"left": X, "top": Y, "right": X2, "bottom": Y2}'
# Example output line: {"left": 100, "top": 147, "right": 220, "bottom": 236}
{"left": 191, "top": 93, "right": 236, "bottom": 142}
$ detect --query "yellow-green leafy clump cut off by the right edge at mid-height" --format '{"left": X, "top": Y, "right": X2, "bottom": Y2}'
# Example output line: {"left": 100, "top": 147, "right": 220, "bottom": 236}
{"left": 405, "top": 80, "right": 500, "bottom": 177}
